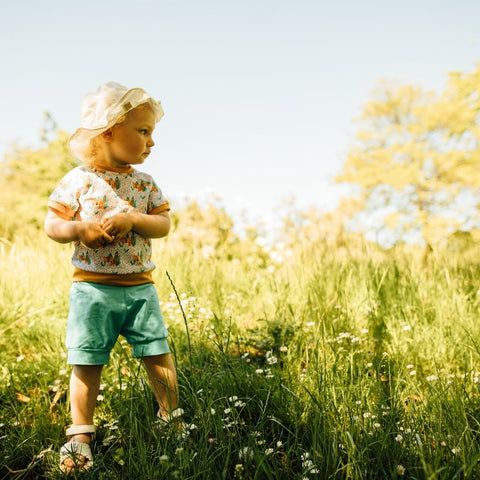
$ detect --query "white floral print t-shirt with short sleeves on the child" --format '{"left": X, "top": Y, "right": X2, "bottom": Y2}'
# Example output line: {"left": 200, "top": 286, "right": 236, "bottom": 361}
{"left": 48, "top": 165, "right": 170, "bottom": 283}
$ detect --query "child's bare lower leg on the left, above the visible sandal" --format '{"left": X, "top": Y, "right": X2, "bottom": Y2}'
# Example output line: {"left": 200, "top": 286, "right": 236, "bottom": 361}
{"left": 70, "top": 365, "right": 103, "bottom": 443}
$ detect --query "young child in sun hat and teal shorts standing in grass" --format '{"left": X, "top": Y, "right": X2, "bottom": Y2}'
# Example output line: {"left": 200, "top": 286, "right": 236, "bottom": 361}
{"left": 45, "top": 82, "right": 181, "bottom": 473}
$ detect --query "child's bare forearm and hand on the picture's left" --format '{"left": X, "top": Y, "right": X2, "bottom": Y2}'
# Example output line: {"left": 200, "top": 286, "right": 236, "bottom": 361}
{"left": 45, "top": 210, "right": 113, "bottom": 248}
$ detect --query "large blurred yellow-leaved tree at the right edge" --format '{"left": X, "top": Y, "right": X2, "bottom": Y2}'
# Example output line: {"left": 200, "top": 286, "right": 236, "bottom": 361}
{"left": 336, "top": 63, "right": 480, "bottom": 244}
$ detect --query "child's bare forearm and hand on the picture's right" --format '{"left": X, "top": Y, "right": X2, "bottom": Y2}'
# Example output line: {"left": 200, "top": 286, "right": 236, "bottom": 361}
{"left": 103, "top": 211, "right": 170, "bottom": 238}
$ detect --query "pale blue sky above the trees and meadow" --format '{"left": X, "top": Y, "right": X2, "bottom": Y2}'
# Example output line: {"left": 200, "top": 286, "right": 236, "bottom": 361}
{"left": 0, "top": 0, "right": 480, "bottom": 226}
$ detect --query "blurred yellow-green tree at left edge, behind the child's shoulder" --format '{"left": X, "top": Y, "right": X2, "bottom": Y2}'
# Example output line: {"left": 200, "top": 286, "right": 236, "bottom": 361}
{"left": 0, "top": 114, "right": 77, "bottom": 240}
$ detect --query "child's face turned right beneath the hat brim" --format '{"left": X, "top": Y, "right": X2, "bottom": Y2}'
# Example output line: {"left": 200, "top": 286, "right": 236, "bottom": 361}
{"left": 104, "top": 104, "right": 155, "bottom": 167}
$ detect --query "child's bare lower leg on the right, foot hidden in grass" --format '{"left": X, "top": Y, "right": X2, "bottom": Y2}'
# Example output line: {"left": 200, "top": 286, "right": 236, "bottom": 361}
{"left": 142, "top": 353, "right": 178, "bottom": 417}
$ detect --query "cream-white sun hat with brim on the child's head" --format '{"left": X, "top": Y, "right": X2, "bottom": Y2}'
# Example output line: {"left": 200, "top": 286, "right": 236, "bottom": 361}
{"left": 68, "top": 82, "right": 163, "bottom": 161}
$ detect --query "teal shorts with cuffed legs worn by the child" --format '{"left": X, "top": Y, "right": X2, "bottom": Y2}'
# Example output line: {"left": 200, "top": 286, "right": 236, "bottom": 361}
{"left": 66, "top": 282, "right": 170, "bottom": 365}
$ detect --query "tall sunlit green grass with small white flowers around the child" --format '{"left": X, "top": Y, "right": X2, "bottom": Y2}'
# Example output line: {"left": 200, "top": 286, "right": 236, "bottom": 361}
{"left": 0, "top": 234, "right": 480, "bottom": 479}
